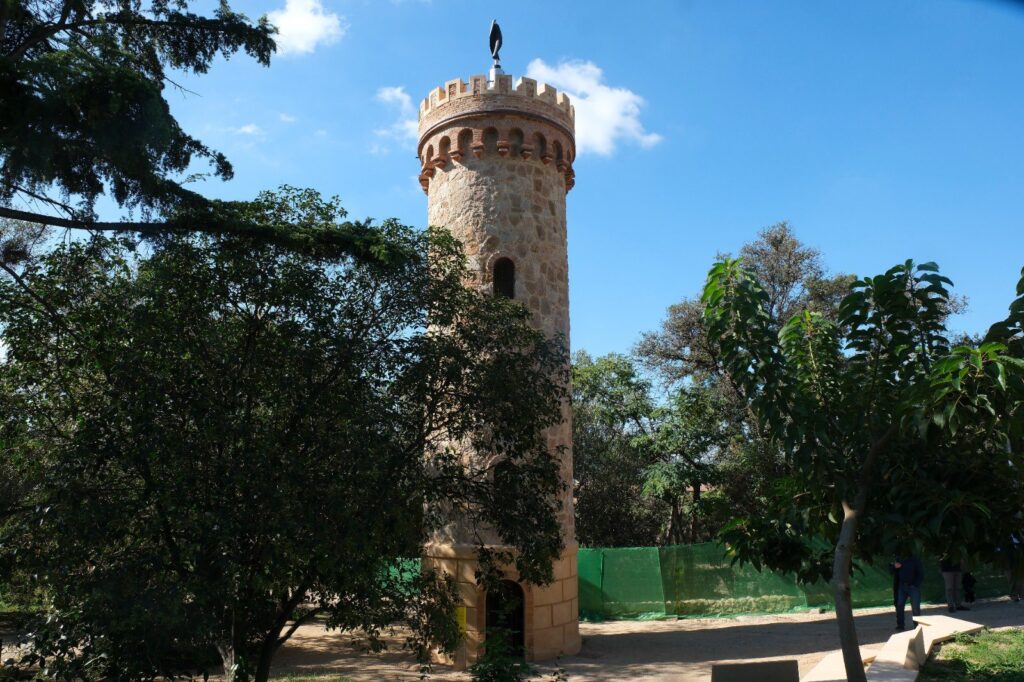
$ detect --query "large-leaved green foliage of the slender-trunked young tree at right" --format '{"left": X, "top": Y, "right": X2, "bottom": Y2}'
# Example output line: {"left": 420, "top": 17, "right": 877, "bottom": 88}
{"left": 705, "top": 254, "right": 1019, "bottom": 579}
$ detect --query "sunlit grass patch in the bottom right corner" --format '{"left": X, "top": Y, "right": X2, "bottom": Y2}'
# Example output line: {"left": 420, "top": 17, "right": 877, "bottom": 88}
{"left": 919, "top": 630, "right": 1024, "bottom": 682}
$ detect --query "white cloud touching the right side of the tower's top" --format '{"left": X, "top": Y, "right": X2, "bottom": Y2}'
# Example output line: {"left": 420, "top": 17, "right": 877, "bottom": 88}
{"left": 526, "top": 59, "right": 662, "bottom": 157}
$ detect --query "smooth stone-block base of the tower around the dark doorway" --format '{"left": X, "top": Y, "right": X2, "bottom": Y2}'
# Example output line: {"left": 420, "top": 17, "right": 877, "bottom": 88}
{"left": 423, "top": 544, "right": 582, "bottom": 670}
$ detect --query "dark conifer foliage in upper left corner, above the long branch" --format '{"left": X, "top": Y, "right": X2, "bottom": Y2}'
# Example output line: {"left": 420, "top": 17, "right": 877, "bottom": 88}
{"left": 0, "top": 0, "right": 274, "bottom": 216}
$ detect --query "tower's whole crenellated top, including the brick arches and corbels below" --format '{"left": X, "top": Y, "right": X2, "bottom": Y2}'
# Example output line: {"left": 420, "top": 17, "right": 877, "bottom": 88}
{"left": 417, "top": 70, "right": 575, "bottom": 193}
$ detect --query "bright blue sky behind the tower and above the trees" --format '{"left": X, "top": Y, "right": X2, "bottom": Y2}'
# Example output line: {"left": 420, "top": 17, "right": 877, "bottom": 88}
{"left": 159, "top": 0, "right": 1024, "bottom": 353}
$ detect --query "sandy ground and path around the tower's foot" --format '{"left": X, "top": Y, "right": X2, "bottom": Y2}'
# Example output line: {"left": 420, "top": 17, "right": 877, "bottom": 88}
{"left": 273, "top": 599, "right": 1024, "bottom": 682}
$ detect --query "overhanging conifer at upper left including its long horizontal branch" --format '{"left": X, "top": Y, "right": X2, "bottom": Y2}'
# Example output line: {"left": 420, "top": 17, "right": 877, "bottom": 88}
{"left": 0, "top": 0, "right": 384, "bottom": 258}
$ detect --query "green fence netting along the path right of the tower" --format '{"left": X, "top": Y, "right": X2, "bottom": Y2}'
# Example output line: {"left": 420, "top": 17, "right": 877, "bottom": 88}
{"left": 578, "top": 543, "right": 1006, "bottom": 621}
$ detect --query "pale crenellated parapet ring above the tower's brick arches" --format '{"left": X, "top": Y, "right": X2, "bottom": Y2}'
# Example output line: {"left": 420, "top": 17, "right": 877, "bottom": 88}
{"left": 420, "top": 74, "right": 575, "bottom": 137}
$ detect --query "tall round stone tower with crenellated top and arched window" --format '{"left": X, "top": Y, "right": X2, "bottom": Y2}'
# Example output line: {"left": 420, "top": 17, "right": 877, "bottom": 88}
{"left": 418, "top": 69, "right": 581, "bottom": 668}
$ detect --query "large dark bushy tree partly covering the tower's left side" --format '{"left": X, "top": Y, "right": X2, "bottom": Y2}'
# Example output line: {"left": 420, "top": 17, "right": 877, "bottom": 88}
{"left": 0, "top": 191, "right": 567, "bottom": 682}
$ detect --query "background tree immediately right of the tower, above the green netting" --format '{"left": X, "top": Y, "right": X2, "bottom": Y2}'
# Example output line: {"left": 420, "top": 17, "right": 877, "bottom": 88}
{"left": 572, "top": 351, "right": 665, "bottom": 547}
